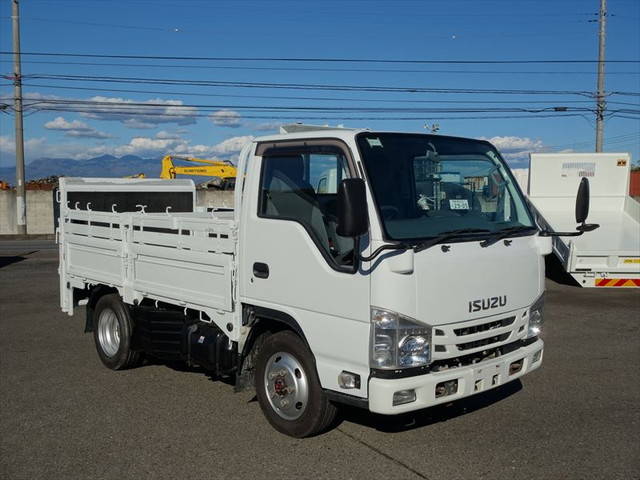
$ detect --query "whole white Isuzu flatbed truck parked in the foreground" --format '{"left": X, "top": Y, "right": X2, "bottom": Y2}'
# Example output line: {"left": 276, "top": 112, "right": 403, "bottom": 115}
{"left": 58, "top": 128, "right": 588, "bottom": 437}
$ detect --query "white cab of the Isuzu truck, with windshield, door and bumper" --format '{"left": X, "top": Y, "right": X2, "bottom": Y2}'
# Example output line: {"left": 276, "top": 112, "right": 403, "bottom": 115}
{"left": 236, "top": 126, "right": 550, "bottom": 420}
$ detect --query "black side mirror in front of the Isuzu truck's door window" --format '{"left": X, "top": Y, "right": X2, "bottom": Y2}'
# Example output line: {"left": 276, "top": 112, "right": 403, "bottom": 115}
{"left": 336, "top": 178, "right": 369, "bottom": 237}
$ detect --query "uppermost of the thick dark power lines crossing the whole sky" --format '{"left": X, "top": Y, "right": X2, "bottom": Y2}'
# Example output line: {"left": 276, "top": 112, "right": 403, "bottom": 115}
{"left": 0, "top": 51, "right": 640, "bottom": 65}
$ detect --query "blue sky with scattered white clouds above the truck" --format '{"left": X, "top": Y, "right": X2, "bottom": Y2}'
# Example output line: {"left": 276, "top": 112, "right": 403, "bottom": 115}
{"left": 0, "top": 0, "right": 640, "bottom": 170}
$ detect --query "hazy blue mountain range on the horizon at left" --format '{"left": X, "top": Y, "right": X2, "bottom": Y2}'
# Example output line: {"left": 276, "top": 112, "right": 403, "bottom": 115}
{"left": 0, "top": 155, "right": 168, "bottom": 185}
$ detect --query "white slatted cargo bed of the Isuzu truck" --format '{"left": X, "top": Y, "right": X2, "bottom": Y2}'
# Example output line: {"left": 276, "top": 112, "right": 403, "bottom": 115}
{"left": 59, "top": 178, "right": 236, "bottom": 340}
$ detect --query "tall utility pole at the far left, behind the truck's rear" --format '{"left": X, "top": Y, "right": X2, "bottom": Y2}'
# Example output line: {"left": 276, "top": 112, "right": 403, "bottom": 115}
{"left": 11, "top": 0, "right": 27, "bottom": 235}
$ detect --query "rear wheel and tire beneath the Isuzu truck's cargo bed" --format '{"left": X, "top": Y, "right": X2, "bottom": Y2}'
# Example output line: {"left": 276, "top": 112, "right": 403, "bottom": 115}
{"left": 93, "top": 293, "right": 142, "bottom": 370}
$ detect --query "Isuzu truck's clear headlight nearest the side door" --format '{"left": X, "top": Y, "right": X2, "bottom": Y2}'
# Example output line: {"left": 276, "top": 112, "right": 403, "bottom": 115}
{"left": 371, "top": 307, "right": 431, "bottom": 369}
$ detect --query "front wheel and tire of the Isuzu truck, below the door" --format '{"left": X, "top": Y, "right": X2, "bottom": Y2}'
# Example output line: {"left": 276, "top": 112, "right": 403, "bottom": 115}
{"left": 255, "top": 330, "right": 337, "bottom": 438}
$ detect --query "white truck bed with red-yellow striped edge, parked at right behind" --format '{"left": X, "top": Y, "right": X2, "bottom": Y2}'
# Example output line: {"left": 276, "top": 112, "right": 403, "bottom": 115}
{"left": 528, "top": 153, "right": 640, "bottom": 288}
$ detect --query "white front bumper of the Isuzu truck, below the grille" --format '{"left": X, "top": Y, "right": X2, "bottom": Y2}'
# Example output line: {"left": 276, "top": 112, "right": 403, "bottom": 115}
{"left": 369, "top": 339, "right": 544, "bottom": 415}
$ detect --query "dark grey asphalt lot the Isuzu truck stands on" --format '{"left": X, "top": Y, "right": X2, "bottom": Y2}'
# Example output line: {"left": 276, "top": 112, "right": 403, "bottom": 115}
{"left": 0, "top": 242, "right": 640, "bottom": 480}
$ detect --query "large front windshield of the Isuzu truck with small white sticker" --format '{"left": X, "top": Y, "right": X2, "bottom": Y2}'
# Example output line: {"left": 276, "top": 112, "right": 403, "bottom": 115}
{"left": 358, "top": 132, "right": 534, "bottom": 240}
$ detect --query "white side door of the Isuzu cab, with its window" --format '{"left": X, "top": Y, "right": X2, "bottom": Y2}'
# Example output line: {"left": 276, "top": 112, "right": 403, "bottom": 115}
{"left": 240, "top": 141, "right": 370, "bottom": 396}
